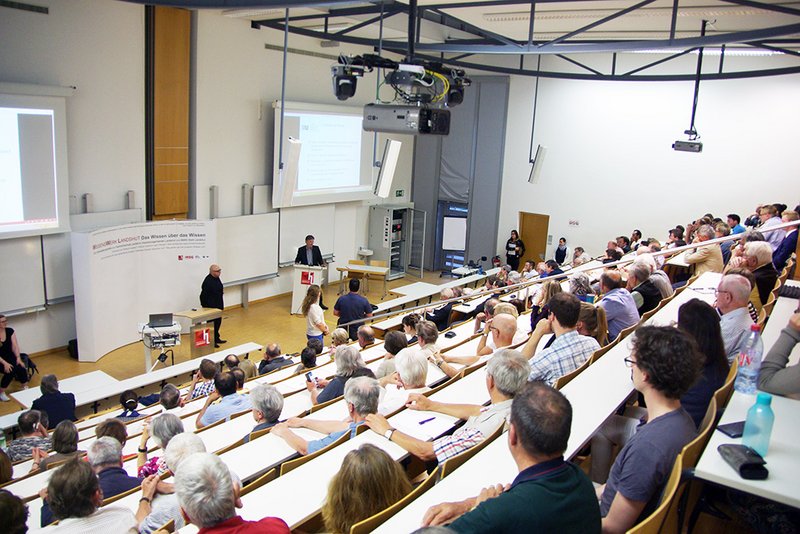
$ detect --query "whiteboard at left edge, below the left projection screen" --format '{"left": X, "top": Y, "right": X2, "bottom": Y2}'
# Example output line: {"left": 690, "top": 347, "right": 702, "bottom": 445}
{"left": 0, "top": 236, "right": 44, "bottom": 313}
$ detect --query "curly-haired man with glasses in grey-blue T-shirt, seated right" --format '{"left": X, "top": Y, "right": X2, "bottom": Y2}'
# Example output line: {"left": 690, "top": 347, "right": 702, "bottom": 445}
{"left": 592, "top": 326, "right": 701, "bottom": 532}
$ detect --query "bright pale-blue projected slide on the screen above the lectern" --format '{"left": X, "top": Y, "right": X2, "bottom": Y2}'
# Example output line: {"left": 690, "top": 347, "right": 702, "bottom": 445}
{"left": 294, "top": 113, "right": 362, "bottom": 191}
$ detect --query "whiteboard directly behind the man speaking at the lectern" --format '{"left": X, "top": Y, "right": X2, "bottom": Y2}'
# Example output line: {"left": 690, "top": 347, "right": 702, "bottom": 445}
{"left": 280, "top": 204, "right": 336, "bottom": 265}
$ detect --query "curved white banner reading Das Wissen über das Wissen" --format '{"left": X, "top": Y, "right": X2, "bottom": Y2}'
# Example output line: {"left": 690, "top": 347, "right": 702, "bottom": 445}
{"left": 72, "top": 221, "right": 217, "bottom": 361}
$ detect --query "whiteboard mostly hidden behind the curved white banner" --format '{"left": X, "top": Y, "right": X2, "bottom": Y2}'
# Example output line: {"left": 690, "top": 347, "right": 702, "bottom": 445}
{"left": 42, "top": 209, "right": 142, "bottom": 304}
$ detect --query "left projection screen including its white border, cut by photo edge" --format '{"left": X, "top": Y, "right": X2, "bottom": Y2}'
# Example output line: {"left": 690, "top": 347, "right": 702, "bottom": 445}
{"left": 0, "top": 94, "right": 69, "bottom": 239}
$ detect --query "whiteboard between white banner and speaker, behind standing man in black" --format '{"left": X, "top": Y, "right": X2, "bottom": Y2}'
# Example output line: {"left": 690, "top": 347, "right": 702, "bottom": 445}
{"left": 214, "top": 212, "right": 278, "bottom": 285}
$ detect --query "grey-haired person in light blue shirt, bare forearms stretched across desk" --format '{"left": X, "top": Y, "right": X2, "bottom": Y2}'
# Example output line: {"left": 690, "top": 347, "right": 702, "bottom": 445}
{"left": 271, "top": 376, "right": 381, "bottom": 455}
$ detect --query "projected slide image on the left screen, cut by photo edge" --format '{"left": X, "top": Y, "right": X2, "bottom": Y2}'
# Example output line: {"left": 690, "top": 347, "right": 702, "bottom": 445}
{"left": 0, "top": 107, "right": 58, "bottom": 233}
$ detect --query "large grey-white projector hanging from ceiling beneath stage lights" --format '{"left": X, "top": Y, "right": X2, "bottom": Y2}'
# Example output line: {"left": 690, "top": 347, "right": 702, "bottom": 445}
{"left": 361, "top": 104, "right": 450, "bottom": 135}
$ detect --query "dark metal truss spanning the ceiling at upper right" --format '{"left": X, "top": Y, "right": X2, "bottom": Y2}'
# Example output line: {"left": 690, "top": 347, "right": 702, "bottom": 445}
{"left": 252, "top": 0, "right": 800, "bottom": 81}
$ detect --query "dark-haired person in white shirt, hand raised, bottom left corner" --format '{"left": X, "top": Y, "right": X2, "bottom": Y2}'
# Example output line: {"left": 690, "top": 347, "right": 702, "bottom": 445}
{"left": 42, "top": 458, "right": 158, "bottom": 534}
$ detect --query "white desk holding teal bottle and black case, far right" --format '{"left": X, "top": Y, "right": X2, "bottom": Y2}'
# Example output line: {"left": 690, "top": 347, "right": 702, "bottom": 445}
{"left": 695, "top": 391, "right": 800, "bottom": 508}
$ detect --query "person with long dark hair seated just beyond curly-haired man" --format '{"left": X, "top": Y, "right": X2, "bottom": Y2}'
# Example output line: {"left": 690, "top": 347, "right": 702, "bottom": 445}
{"left": 678, "top": 299, "right": 729, "bottom": 428}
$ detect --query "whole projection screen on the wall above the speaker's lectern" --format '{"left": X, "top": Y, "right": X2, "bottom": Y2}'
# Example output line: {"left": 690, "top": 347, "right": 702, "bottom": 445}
{"left": 272, "top": 102, "right": 373, "bottom": 207}
